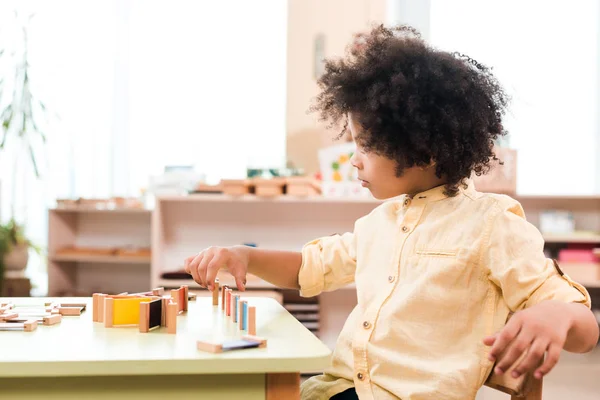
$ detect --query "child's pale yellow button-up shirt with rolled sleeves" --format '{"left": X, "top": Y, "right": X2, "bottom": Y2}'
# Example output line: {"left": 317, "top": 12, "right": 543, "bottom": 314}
{"left": 299, "top": 181, "right": 590, "bottom": 400}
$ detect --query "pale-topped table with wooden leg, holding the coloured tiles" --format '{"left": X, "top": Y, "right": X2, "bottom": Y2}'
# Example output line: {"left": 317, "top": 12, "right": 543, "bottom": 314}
{"left": 0, "top": 297, "right": 330, "bottom": 400}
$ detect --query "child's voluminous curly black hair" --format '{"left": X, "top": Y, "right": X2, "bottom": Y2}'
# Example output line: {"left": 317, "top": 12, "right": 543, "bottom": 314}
{"left": 310, "top": 25, "right": 508, "bottom": 196}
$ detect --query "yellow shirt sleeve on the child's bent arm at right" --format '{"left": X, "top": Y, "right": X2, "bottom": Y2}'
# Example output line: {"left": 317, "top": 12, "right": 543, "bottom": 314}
{"left": 483, "top": 200, "right": 591, "bottom": 312}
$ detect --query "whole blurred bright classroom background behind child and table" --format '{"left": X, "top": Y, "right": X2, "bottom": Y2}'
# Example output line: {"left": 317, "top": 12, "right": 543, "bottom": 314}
{"left": 0, "top": 0, "right": 600, "bottom": 399}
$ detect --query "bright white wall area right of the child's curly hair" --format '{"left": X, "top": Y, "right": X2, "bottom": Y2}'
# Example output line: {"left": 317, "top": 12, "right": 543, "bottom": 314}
{"left": 388, "top": 0, "right": 600, "bottom": 195}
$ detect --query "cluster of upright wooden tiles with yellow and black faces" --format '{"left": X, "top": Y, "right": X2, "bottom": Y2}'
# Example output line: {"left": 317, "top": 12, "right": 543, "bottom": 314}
{"left": 93, "top": 285, "right": 189, "bottom": 334}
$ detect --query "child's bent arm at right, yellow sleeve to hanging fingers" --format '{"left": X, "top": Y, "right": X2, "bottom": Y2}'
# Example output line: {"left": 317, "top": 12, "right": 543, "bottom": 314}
{"left": 482, "top": 202, "right": 598, "bottom": 377}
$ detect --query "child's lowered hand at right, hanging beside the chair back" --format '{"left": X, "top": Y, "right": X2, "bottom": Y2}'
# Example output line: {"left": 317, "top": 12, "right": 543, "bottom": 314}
{"left": 483, "top": 300, "right": 572, "bottom": 379}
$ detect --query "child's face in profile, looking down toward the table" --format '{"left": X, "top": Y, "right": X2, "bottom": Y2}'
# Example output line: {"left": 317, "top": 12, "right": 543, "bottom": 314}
{"left": 348, "top": 114, "right": 444, "bottom": 200}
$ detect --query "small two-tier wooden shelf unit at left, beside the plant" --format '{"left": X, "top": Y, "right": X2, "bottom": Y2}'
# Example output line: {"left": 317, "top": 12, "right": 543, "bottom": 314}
{"left": 48, "top": 208, "right": 152, "bottom": 296}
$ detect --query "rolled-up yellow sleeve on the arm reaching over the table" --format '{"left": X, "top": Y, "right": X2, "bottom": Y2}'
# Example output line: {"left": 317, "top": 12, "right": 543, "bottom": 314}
{"left": 298, "top": 232, "right": 356, "bottom": 297}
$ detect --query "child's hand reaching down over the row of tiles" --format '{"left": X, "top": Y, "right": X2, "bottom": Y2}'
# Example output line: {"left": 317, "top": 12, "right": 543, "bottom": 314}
{"left": 184, "top": 246, "right": 249, "bottom": 291}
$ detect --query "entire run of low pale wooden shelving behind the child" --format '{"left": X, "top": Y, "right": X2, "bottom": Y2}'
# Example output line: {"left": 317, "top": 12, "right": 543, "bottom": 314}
{"left": 48, "top": 194, "right": 600, "bottom": 348}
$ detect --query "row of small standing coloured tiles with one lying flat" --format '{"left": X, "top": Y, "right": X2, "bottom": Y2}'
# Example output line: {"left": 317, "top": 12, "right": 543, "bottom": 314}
{"left": 196, "top": 279, "right": 267, "bottom": 353}
